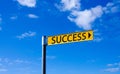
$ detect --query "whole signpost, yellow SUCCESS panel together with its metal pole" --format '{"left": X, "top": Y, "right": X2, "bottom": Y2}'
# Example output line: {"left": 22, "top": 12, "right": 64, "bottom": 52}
{"left": 42, "top": 30, "right": 93, "bottom": 74}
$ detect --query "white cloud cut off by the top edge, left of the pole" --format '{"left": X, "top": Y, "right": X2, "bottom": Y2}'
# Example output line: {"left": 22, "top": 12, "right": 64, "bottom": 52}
{"left": 17, "top": 0, "right": 36, "bottom": 7}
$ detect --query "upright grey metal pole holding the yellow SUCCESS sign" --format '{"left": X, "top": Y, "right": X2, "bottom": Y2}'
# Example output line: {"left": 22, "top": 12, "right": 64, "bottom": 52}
{"left": 42, "top": 36, "right": 47, "bottom": 74}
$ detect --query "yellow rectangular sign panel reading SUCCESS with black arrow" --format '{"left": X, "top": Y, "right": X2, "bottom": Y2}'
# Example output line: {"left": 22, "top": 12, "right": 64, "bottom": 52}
{"left": 47, "top": 30, "right": 93, "bottom": 45}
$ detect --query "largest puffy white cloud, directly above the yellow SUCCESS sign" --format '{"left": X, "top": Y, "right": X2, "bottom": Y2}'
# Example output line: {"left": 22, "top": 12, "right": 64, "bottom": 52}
{"left": 68, "top": 6, "right": 103, "bottom": 30}
